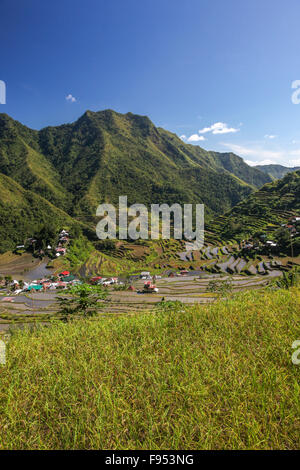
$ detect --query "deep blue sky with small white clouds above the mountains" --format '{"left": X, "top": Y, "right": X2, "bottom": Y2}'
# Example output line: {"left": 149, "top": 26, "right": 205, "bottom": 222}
{"left": 0, "top": 0, "right": 300, "bottom": 166}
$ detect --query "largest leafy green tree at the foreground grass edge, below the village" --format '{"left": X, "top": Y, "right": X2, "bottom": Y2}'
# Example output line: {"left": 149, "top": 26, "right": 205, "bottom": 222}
{"left": 58, "top": 284, "right": 108, "bottom": 321}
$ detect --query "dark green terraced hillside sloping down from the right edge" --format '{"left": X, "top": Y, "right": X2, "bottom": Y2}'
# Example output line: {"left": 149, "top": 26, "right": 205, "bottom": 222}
{"left": 207, "top": 170, "right": 300, "bottom": 240}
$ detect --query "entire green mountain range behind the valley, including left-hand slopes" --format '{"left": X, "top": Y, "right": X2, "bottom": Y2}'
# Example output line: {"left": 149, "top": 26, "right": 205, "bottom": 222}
{"left": 0, "top": 110, "right": 271, "bottom": 252}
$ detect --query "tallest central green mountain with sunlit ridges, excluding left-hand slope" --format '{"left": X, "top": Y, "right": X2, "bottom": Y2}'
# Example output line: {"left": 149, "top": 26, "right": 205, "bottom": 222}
{"left": 32, "top": 110, "right": 265, "bottom": 218}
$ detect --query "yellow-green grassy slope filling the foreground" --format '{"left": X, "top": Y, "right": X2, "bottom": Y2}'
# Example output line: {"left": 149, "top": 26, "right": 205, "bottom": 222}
{"left": 0, "top": 288, "right": 300, "bottom": 449}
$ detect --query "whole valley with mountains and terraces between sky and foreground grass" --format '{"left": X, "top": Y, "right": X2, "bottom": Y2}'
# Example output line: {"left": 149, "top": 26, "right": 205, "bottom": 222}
{"left": 0, "top": 110, "right": 300, "bottom": 329}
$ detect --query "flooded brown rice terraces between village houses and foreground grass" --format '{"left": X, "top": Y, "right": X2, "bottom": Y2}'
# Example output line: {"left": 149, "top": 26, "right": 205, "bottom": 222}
{"left": 0, "top": 273, "right": 280, "bottom": 331}
